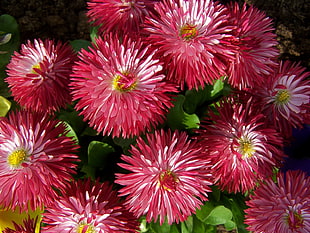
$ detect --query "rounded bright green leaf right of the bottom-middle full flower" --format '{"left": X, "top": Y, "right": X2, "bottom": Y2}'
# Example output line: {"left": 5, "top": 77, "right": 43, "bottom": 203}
{"left": 204, "top": 205, "right": 233, "bottom": 226}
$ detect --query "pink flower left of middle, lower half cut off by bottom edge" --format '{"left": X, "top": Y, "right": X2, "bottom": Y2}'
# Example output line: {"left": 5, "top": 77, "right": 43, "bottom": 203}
{"left": 42, "top": 179, "right": 139, "bottom": 233}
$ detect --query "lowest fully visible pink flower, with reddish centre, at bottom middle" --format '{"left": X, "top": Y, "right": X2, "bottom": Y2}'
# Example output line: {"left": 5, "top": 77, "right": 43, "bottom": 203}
{"left": 116, "top": 130, "right": 212, "bottom": 224}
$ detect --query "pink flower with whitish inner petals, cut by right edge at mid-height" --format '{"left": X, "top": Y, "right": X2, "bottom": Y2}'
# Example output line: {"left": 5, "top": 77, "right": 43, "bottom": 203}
{"left": 252, "top": 61, "right": 310, "bottom": 138}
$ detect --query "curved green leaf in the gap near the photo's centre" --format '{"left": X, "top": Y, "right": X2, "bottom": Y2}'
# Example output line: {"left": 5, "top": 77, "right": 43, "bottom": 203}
{"left": 167, "top": 95, "right": 200, "bottom": 130}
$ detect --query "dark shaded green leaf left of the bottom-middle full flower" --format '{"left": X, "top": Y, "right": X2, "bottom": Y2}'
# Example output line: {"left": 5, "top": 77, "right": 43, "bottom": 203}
{"left": 88, "top": 141, "right": 115, "bottom": 168}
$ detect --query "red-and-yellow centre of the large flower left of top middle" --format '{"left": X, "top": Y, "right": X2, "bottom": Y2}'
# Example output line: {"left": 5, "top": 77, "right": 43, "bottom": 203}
{"left": 113, "top": 72, "right": 137, "bottom": 92}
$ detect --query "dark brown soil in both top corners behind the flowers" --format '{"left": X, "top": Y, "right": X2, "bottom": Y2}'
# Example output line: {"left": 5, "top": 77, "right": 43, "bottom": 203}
{"left": 0, "top": 0, "right": 310, "bottom": 69}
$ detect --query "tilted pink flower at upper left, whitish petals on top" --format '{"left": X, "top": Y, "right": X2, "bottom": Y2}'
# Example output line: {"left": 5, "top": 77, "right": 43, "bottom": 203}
{"left": 5, "top": 39, "right": 75, "bottom": 112}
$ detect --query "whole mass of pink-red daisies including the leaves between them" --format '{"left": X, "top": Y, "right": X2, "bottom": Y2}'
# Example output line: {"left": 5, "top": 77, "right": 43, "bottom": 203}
{"left": 0, "top": 0, "right": 310, "bottom": 233}
